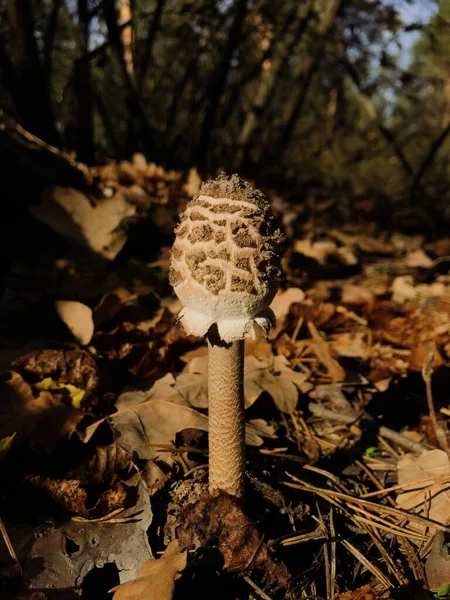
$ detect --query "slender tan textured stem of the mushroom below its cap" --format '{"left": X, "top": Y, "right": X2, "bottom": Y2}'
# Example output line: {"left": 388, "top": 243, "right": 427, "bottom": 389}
{"left": 208, "top": 334, "right": 245, "bottom": 498}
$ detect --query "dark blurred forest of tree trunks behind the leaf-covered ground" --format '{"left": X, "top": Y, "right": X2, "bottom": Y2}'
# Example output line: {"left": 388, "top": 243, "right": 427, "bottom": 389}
{"left": 0, "top": 0, "right": 450, "bottom": 221}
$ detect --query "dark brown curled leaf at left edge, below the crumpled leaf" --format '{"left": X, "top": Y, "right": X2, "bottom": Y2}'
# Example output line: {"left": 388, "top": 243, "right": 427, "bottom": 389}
{"left": 0, "top": 371, "right": 83, "bottom": 452}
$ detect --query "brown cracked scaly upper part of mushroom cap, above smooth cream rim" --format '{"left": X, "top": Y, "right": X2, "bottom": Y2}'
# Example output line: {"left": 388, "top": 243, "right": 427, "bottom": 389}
{"left": 169, "top": 175, "right": 281, "bottom": 295}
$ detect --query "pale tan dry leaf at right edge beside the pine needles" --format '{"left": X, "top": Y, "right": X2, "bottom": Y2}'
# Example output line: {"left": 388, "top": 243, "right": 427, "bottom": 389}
{"left": 397, "top": 449, "right": 450, "bottom": 533}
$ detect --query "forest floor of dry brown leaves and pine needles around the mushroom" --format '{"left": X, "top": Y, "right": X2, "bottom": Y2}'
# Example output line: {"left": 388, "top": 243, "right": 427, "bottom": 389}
{"left": 0, "top": 161, "right": 450, "bottom": 600}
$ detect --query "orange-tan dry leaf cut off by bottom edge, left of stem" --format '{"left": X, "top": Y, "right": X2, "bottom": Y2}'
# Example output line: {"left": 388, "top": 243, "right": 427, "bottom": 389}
{"left": 110, "top": 540, "right": 187, "bottom": 600}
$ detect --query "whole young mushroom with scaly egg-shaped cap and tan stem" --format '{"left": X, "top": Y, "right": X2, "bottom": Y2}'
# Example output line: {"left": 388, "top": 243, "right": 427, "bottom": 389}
{"left": 169, "top": 174, "right": 281, "bottom": 498}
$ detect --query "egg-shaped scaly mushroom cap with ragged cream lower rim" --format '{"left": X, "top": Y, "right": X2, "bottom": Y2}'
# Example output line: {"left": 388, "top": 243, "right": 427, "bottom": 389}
{"left": 169, "top": 174, "right": 281, "bottom": 342}
